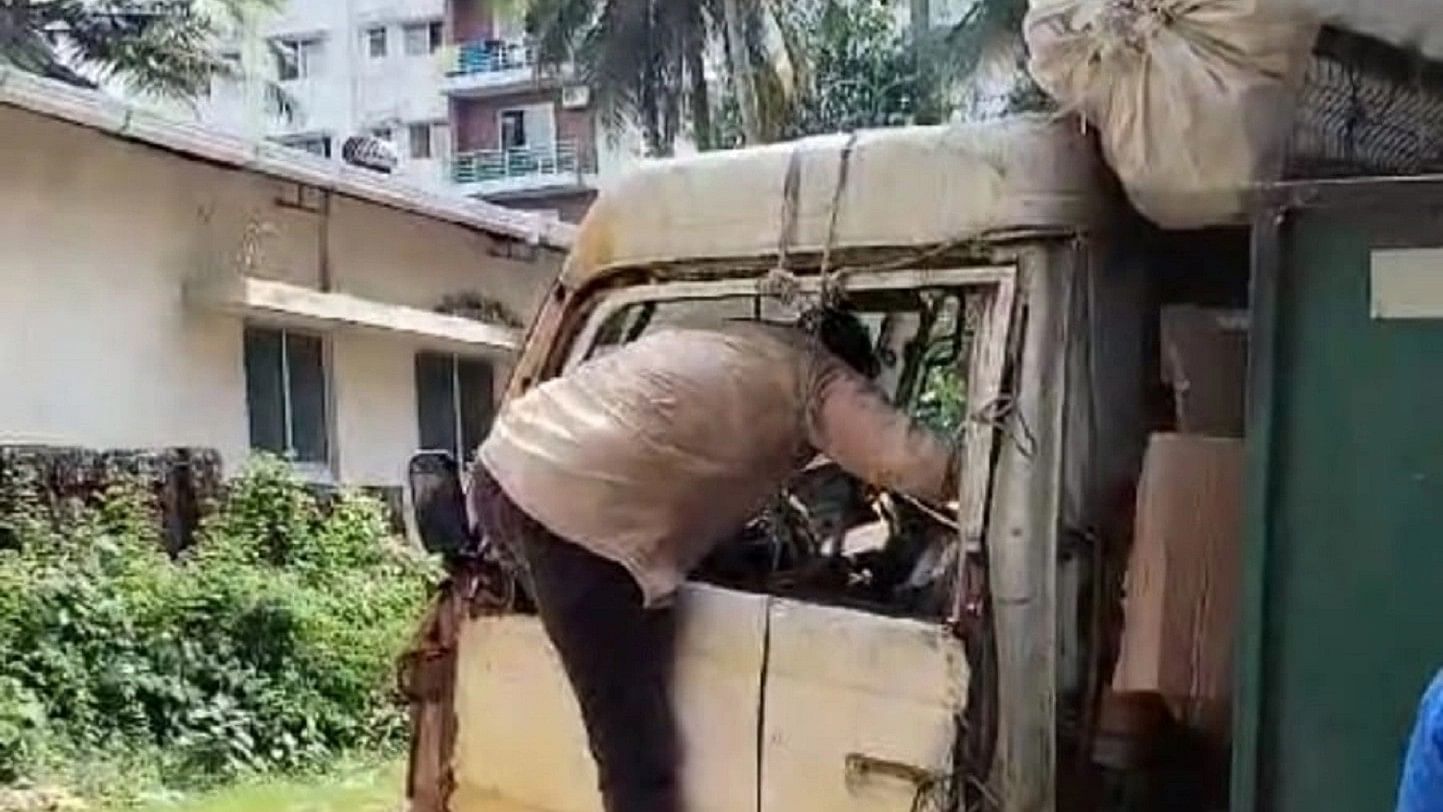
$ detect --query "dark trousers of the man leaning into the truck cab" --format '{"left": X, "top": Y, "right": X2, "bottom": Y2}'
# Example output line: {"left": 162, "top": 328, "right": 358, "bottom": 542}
{"left": 473, "top": 467, "right": 680, "bottom": 812}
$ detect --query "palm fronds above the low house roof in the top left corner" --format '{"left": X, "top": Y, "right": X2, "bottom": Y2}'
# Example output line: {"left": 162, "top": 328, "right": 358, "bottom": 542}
{"left": 0, "top": 0, "right": 284, "bottom": 101}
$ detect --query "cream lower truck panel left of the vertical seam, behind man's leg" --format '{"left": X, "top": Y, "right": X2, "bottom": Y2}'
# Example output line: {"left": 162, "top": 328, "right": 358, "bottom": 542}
{"left": 452, "top": 586, "right": 766, "bottom": 812}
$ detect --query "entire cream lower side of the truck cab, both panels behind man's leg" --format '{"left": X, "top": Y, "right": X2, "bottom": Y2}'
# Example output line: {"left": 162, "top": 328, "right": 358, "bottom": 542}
{"left": 450, "top": 584, "right": 967, "bottom": 812}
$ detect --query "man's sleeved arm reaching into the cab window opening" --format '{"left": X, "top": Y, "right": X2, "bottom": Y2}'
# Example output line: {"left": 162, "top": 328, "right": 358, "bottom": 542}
{"left": 807, "top": 359, "right": 958, "bottom": 503}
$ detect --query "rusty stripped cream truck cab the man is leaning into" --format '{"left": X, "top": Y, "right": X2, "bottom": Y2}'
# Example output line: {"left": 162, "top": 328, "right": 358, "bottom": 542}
{"left": 403, "top": 118, "right": 1146, "bottom": 812}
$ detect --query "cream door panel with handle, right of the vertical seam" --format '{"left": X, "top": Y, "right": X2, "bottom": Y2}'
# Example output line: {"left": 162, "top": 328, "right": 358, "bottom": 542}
{"left": 756, "top": 600, "right": 968, "bottom": 812}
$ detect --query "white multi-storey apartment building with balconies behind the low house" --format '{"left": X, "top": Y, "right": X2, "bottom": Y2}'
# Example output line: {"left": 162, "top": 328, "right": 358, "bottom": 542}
{"left": 163, "top": 0, "right": 614, "bottom": 221}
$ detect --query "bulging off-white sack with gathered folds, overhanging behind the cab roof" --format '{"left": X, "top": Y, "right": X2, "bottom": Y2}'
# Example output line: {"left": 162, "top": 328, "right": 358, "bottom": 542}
{"left": 1025, "top": 0, "right": 1317, "bottom": 228}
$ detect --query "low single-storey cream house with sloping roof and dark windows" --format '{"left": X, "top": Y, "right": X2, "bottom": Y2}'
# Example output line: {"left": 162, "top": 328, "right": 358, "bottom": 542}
{"left": 0, "top": 68, "right": 571, "bottom": 487}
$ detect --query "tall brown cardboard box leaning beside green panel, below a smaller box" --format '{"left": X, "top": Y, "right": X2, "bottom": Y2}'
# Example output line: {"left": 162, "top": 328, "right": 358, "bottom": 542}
{"left": 1113, "top": 434, "right": 1244, "bottom": 747}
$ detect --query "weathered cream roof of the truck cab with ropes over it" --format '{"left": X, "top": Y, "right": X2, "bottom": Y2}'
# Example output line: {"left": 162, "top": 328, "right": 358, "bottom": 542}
{"left": 561, "top": 115, "right": 1107, "bottom": 288}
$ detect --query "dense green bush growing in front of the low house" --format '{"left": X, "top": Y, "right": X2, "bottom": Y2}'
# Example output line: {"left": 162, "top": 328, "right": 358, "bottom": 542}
{"left": 0, "top": 460, "right": 436, "bottom": 801}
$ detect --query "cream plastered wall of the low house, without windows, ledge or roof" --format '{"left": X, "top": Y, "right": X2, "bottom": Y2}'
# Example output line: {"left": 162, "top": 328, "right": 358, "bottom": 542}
{"left": 0, "top": 108, "right": 560, "bottom": 485}
